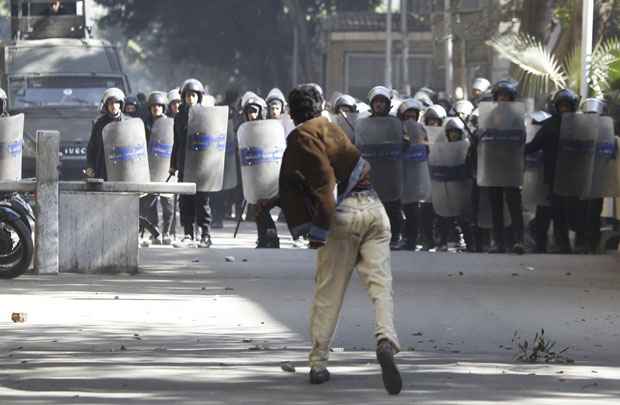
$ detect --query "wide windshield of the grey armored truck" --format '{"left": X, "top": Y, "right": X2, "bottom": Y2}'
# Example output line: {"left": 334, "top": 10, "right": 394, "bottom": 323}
{"left": 9, "top": 76, "right": 124, "bottom": 108}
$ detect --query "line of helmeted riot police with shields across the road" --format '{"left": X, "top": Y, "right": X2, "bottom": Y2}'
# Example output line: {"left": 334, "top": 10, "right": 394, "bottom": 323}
{"left": 2, "top": 78, "right": 620, "bottom": 253}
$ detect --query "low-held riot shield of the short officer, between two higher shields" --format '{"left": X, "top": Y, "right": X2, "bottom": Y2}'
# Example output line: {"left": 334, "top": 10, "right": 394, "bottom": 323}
{"left": 428, "top": 139, "right": 473, "bottom": 217}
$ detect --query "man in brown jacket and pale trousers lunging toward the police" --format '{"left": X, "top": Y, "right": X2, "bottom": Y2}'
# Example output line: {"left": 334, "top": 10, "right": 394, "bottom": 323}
{"left": 258, "top": 84, "right": 402, "bottom": 395}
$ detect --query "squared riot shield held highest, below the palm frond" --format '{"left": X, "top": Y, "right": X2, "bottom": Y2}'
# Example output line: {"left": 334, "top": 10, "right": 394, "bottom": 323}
{"left": 477, "top": 102, "right": 526, "bottom": 187}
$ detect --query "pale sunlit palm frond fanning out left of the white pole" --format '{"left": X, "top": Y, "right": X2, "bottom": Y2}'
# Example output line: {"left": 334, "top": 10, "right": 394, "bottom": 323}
{"left": 487, "top": 34, "right": 566, "bottom": 96}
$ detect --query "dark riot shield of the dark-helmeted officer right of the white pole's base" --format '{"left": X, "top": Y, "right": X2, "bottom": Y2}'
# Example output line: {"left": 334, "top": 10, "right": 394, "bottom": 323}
{"left": 553, "top": 113, "right": 599, "bottom": 197}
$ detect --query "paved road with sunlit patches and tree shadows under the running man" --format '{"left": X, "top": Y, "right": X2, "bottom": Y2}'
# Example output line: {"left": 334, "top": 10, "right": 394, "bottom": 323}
{"left": 0, "top": 224, "right": 620, "bottom": 405}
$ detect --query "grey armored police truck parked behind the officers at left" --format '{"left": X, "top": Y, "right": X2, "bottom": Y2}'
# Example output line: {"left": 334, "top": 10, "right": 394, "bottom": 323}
{"left": 0, "top": 0, "right": 130, "bottom": 180}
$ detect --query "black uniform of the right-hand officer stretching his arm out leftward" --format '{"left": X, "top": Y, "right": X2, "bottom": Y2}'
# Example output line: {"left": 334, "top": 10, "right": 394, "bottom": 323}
{"left": 525, "top": 114, "right": 571, "bottom": 253}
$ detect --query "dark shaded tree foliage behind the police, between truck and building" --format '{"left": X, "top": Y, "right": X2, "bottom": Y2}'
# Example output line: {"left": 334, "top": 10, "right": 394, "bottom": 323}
{"left": 96, "top": 0, "right": 380, "bottom": 91}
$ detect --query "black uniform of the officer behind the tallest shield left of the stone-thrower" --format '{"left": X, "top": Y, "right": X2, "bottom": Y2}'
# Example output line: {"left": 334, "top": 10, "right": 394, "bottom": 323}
{"left": 170, "top": 104, "right": 211, "bottom": 239}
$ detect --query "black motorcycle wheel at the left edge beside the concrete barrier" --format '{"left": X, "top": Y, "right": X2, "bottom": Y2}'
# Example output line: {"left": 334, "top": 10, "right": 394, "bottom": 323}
{"left": 0, "top": 216, "right": 34, "bottom": 279}
